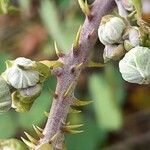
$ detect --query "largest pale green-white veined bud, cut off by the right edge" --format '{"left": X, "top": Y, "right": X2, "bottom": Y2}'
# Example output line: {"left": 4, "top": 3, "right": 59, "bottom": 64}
{"left": 119, "top": 46, "right": 150, "bottom": 84}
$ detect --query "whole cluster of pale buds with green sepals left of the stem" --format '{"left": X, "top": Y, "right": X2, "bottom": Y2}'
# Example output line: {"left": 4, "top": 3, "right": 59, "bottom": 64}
{"left": 0, "top": 57, "right": 50, "bottom": 112}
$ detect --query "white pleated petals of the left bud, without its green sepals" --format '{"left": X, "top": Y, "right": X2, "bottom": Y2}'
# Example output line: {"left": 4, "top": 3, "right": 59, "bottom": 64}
{"left": 5, "top": 57, "right": 39, "bottom": 89}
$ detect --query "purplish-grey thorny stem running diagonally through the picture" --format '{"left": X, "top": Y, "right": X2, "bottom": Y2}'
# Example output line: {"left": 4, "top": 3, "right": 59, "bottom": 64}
{"left": 36, "top": 0, "right": 115, "bottom": 150}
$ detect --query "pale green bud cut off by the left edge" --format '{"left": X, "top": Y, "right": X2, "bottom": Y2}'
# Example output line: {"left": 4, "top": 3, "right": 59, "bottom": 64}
{"left": 0, "top": 77, "right": 12, "bottom": 112}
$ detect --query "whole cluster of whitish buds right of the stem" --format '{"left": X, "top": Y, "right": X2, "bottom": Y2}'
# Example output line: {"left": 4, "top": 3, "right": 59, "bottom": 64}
{"left": 98, "top": 0, "right": 150, "bottom": 84}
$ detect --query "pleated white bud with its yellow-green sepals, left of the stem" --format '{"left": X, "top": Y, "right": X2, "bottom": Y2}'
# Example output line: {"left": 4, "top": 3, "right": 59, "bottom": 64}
{"left": 3, "top": 57, "right": 50, "bottom": 89}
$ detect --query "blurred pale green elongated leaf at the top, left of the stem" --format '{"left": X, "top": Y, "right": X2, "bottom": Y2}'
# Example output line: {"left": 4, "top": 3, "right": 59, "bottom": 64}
{"left": 40, "top": 0, "right": 69, "bottom": 50}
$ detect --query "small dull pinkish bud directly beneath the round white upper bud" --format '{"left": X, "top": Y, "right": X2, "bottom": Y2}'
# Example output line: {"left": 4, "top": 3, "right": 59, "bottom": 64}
{"left": 103, "top": 44, "right": 125, "bottom": 63}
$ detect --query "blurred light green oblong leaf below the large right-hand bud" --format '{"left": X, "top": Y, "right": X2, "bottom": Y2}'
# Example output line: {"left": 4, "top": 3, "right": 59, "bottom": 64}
{"left": 89, "top": 71, "right": 122, "bottom": 131}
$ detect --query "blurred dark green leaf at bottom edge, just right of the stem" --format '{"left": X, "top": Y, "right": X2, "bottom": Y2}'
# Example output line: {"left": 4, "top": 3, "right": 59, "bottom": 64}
{"left": 66, "top": 116, "right": 107, "bottom": 150}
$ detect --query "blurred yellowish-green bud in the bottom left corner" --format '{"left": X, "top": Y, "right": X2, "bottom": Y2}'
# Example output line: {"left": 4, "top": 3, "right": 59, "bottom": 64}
{"left": 0, "top": 139, "right": 28, "bottom": 150}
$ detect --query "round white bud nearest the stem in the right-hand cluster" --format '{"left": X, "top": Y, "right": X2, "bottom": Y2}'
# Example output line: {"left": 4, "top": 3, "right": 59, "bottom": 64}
{"left": 98, "top": 17, "right": 126, "bottom": 45}
